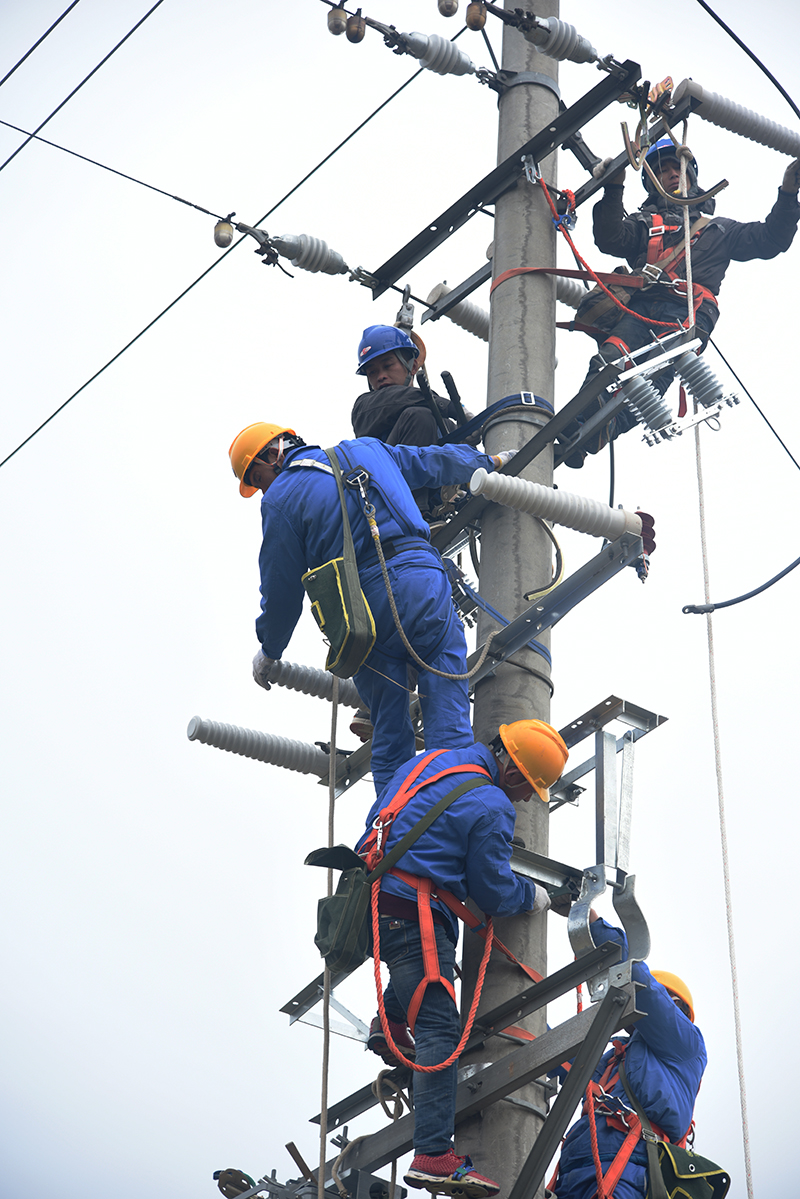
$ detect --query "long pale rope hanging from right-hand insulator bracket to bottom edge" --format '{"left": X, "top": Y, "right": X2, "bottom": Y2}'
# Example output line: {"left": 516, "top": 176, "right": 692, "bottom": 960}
{"left": 694, "top": 424, "right": 753, "bottom": 1199}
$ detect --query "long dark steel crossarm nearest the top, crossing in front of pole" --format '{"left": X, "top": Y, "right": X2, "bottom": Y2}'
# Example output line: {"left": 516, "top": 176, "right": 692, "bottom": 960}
{"left": 371, "top": 61, "right": 642, "bottom": 300}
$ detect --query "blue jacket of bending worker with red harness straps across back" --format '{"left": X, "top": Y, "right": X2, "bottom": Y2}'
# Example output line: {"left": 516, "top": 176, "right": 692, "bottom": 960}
{"left": 356, "top": 741, "right": 536, "bottom": 942}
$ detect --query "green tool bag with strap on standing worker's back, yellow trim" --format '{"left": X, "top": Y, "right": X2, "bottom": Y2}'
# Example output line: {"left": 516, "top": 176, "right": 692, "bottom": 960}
{"left": 302, "top": 448, "right": 375, "bottom": 679}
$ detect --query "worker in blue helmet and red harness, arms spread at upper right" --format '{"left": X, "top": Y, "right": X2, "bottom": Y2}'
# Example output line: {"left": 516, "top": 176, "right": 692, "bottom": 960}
{"left": 563, "top": 138, "right": 800, "bottom": 468}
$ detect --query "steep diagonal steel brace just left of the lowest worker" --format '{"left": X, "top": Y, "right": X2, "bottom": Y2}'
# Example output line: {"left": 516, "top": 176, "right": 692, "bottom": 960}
{"left": 509, "top": 988, "right": 626, "bottom": 1199}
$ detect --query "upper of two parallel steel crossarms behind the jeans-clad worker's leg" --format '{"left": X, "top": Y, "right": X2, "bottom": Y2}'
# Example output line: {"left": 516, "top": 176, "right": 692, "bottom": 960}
{"left": 309, "top": 941, "right": 622, "bottom": 1128}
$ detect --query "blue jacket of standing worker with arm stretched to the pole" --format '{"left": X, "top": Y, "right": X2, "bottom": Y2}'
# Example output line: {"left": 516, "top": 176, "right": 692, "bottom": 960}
{"left": 255, "top": 438, "right": 495, "bottom": 658}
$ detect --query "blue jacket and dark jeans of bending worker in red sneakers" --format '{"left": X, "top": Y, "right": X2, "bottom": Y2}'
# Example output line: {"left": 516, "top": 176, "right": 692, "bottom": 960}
{"left": 356, "top": 742, "right": 536, "bottom": 1157}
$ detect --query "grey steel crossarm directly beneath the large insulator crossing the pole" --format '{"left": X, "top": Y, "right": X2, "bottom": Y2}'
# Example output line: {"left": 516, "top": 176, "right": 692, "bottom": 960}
{"left": 467, "top": 534, "right": 643, "bottom": 688}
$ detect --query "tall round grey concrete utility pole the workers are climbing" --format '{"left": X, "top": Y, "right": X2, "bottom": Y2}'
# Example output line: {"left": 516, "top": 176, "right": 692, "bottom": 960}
{"left": 457, "top": 0, "right": 566, "bottom": 1194}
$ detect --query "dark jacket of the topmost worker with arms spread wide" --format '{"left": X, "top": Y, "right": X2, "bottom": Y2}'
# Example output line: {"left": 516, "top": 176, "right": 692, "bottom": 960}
{"left": 593, "top": 183, "right": 800, "bottom": 318}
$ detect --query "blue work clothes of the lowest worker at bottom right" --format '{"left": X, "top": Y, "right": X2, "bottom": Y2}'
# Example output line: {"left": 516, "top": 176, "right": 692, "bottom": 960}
{"left": 555, "top": 920, "right": 708, "bottom": 1199}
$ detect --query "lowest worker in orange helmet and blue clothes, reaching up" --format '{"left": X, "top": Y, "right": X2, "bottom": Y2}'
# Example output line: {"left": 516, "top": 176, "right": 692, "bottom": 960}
{"left": 551, "top": 909, "right": 708, "bottom": 1199}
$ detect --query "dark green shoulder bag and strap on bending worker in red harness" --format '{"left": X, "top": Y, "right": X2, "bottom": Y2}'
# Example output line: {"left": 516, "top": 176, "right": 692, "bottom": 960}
{"left": 306, "top": 778, "right": 491, "bottom": 974}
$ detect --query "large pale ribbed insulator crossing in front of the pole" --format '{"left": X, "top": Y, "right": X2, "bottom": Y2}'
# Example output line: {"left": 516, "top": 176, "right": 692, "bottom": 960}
{"left": 469, "top": 466, "right": 642, "bottom": 541}
